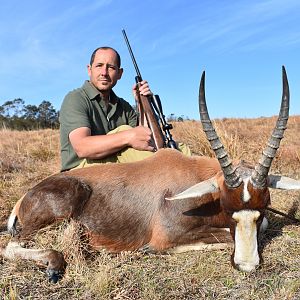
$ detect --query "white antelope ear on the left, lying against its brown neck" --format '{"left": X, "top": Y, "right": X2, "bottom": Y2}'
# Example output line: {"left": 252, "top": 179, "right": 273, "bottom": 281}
{"left": 165, "top": 178, "right": 219, "bottom": 200}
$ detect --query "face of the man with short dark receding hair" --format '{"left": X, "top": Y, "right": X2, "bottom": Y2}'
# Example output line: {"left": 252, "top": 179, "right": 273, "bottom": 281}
{"left": 88, "top": 49, "right": 123, "bottom": 93}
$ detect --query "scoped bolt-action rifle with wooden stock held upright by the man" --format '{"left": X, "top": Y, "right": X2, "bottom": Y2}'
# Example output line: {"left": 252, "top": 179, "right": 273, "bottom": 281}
{"left": 122, "top": 29, "right": 177, "bottom": 150}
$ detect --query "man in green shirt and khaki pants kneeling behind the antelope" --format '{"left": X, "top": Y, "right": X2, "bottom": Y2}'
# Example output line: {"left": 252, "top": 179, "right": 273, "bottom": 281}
{"left": 60, "top": 47, "right": 189, "bottom": 171}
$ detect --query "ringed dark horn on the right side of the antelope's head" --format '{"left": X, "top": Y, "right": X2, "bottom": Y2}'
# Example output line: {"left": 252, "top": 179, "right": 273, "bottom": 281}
{"left": 251, "top": 66, "right": 290, "bottom": 188}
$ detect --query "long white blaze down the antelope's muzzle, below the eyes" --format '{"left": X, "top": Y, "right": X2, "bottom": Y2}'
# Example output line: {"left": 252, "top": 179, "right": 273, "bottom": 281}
{"left": 232, "top": 210, "right": 260, "bottom": 272}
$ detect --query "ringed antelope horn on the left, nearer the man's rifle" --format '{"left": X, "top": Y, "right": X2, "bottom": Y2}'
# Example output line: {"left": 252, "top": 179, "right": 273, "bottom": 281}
{"left": 199, "top": 71, "right": 242, "bottom": 188}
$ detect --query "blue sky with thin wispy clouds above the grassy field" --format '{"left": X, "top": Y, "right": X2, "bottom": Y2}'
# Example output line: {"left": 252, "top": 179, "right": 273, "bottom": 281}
{"left": 0, "top": 0, "right": 300, "bottom": 120}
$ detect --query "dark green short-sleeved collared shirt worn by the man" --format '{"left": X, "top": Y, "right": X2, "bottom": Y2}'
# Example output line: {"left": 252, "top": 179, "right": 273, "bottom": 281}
{"left": 59, "top": 81, "right": 137, "bottom": 171}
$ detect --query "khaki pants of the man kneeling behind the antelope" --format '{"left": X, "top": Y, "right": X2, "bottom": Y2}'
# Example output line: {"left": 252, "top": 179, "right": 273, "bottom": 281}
{"left": 75, "top": 125, "right": 192, "bottom": 169}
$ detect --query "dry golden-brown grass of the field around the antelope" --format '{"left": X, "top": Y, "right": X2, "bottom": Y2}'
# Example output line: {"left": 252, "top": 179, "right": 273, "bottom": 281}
{"left": 0, "top": 116, "right": 300, "bottom": 300}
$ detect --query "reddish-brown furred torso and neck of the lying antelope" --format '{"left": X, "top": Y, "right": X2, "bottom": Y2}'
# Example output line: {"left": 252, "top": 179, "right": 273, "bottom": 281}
{"left": 18, "top": 149, "right": 232, "bottom": 251}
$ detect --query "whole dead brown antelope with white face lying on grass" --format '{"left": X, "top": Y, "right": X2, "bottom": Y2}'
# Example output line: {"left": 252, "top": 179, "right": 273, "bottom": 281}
{"left": 0, "top": 67, "right": 300, "bottom": 281}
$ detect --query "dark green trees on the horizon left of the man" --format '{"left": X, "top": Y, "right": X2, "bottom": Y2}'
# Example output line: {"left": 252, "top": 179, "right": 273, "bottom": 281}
{"left": 0, "top": 98, "right": 59, "bottom": 130}
